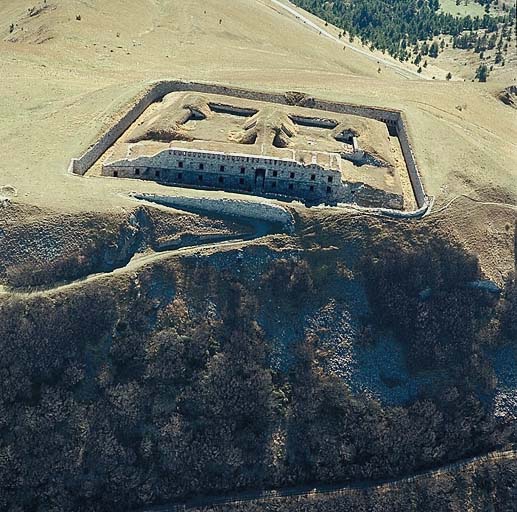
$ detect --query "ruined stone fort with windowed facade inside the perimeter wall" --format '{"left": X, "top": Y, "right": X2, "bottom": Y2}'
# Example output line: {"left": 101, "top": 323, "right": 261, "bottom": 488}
{"left": 77, "top": 82, "right": 428, "bottom": 211}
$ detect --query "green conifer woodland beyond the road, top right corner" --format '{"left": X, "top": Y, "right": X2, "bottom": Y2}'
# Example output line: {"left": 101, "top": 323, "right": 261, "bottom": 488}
{"left": 294, "top": 0, "right": 516, "bottom": 76}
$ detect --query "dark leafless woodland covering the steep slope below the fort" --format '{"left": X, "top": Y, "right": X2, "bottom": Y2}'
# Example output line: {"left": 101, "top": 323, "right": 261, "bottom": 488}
{"left": 0, "top": 217, "right": 515, "bottom": 511}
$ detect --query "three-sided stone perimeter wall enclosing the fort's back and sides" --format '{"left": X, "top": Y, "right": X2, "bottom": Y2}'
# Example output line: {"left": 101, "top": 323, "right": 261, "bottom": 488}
{"left": 70, "top": 81, "right": 430, "bottom": 212}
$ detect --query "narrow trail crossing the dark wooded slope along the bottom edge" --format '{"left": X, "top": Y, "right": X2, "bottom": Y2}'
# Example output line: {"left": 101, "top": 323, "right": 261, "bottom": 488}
{"left": 140, "top": 447, "right": 517, "bottom": 512}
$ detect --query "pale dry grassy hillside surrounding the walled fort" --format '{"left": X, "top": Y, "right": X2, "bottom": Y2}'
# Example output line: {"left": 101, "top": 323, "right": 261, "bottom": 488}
{"left": 0, "top": 0, "right": 517, "bottom": 218}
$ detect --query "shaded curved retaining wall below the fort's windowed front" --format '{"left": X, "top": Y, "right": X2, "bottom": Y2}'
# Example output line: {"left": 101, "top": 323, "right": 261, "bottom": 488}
{"left": 133, "top": 194, "right": 295, "bottom": 233}
